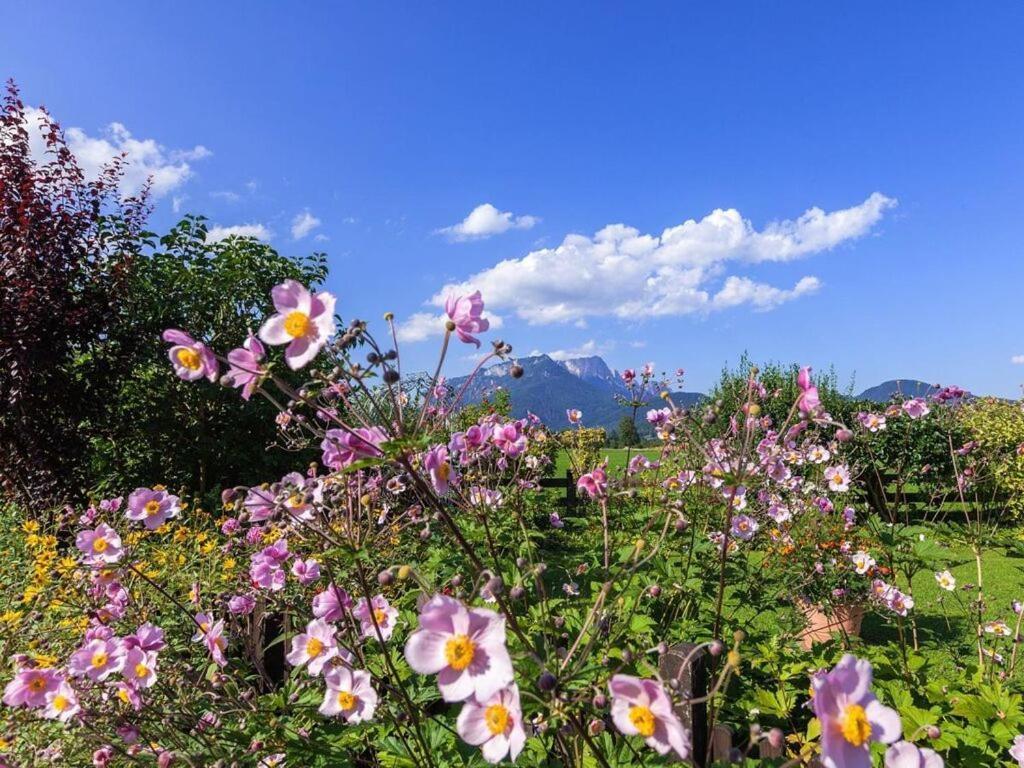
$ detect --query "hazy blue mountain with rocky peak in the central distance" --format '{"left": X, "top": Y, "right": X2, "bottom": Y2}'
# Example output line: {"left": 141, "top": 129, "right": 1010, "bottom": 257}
{"left": 449, "top": 354, "right": 703, "bottom": 431}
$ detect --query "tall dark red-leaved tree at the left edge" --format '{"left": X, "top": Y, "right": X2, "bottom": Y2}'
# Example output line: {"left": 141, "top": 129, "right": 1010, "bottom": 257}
{"left": 0, "top": 83, "right": 147, "bottom": 507}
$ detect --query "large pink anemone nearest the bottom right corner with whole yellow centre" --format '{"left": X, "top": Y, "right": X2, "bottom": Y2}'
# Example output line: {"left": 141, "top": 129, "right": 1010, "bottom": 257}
{"left": 811, "top": 653, "right": 903, "bottom": 768}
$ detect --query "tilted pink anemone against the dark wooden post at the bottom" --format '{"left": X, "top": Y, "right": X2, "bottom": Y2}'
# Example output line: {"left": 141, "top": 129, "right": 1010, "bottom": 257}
{"left": 608, "top": 675, "right": 690, "bottom": 760}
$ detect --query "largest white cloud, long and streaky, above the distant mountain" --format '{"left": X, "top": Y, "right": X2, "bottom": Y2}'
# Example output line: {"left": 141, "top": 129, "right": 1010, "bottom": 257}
{"left": 419, "top": 193, "right": 896, "bottom": 325}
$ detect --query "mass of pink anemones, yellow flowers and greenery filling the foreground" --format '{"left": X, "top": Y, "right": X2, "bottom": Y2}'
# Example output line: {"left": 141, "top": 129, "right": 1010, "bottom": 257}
{"left": 0, "top": 281, "right": 1024, "bottom": 767}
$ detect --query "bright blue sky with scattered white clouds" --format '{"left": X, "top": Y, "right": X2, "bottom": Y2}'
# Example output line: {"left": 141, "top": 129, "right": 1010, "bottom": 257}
{"left": 0, "top": 2, "right": 1024, "bottom": 395}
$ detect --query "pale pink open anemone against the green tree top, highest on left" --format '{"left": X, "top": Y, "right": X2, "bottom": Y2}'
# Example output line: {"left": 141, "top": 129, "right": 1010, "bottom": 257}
{"left": 259, "top": 280, "right": 335, "bottom": 371}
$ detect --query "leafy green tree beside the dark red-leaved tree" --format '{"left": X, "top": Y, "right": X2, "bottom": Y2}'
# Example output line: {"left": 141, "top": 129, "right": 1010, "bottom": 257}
{"left": 86, "top": 216, "right": 327, "bottom": 501}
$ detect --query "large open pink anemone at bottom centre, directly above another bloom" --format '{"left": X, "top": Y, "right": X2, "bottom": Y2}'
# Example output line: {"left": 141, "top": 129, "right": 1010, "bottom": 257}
{"left": 406, "top": 595, "right": 513, "bottom": 701}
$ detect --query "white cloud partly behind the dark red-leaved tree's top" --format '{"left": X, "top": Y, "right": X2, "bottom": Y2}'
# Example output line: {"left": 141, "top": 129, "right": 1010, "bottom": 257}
{"left": 19, "top": 108, "right": 212, "bottom": 199}
